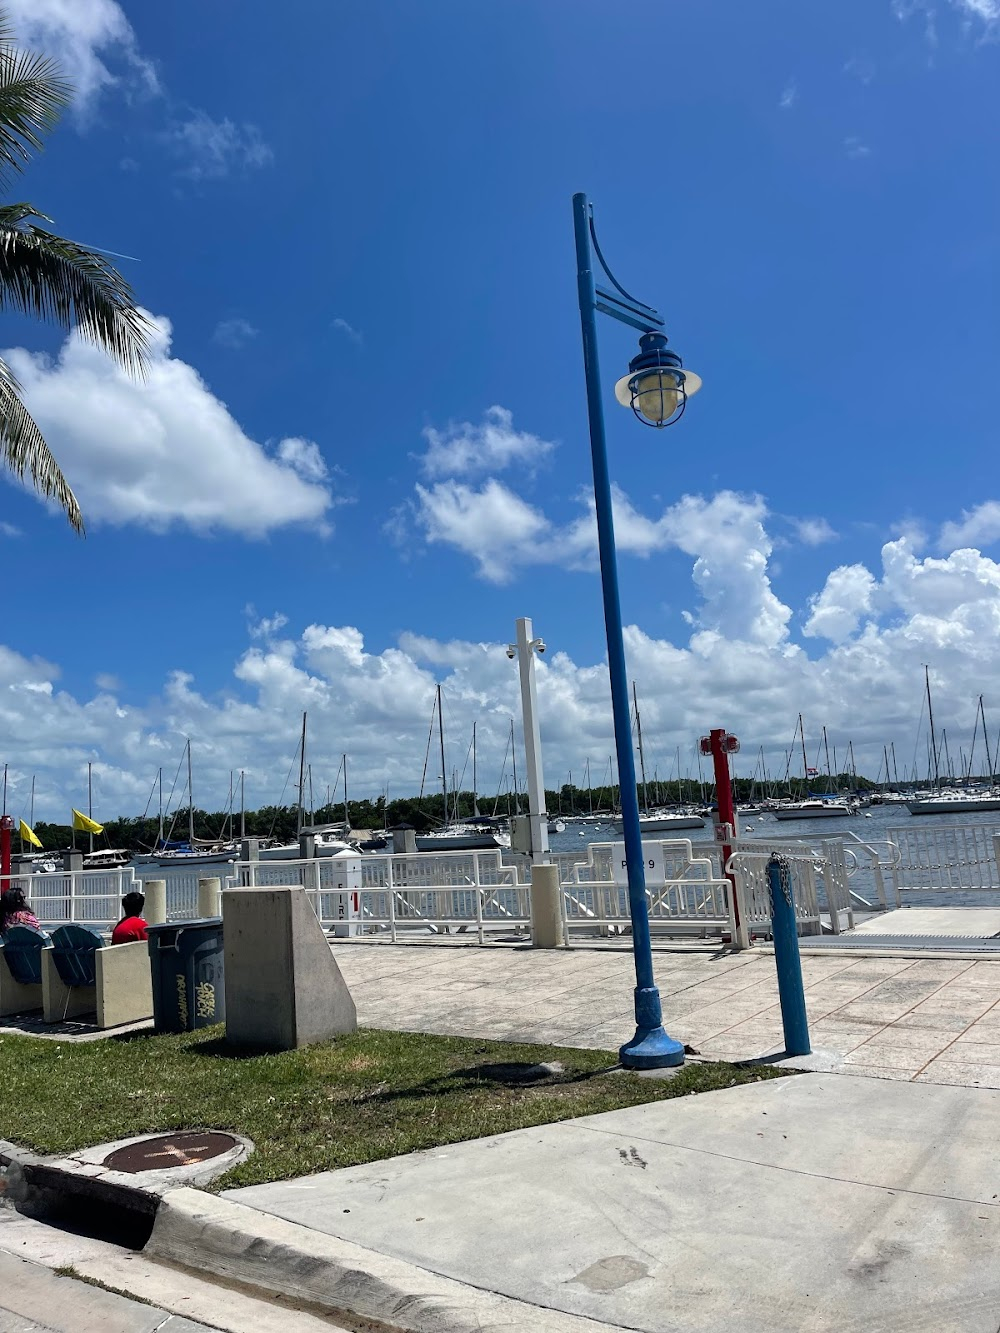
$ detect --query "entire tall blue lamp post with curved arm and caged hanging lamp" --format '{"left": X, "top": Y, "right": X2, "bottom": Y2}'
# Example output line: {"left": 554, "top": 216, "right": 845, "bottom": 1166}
{"left": 573, "top": 195, "right": 701, "bottom": 1069}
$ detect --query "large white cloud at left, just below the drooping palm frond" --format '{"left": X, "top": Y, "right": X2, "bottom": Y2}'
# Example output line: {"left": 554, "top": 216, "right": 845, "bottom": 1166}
{"left": 4, "top": 311, "right": 333, "bottom": 537}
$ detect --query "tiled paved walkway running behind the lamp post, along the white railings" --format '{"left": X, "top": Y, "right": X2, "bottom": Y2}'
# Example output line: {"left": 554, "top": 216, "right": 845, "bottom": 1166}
{"left": 333, "top": 942, "right": 1000, "bottom": 1088}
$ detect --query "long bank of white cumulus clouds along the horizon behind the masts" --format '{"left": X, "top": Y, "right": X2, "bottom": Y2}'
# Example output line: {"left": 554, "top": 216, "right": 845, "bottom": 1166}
{"left": 13, "top": 533, "right": 1000, "bottom": 818}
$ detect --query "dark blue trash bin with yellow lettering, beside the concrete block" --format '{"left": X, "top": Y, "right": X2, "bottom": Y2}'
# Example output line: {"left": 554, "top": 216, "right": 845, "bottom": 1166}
{"left": 148, "top": 917, "right": 225, "bottom": 1032}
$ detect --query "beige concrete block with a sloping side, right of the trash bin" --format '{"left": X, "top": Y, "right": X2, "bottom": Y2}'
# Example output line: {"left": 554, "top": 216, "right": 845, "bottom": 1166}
{"left": 223, "top": 885, "right": 357, "bottom": 1050}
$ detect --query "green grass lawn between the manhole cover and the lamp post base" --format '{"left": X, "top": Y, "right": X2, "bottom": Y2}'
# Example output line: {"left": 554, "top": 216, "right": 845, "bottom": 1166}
{"left": 0, "top": 1026, "right": 779, "bottom": 1186}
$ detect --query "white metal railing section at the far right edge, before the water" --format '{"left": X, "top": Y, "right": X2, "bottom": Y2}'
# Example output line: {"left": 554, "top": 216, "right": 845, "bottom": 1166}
{"left": 888, "top": 824, "right": 1000, "bottom": 906}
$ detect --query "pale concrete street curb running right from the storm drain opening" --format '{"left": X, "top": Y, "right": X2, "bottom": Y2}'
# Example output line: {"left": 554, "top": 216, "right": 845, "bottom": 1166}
{"left": 143, "top": 1188, "right": 618, "bottom": 1333}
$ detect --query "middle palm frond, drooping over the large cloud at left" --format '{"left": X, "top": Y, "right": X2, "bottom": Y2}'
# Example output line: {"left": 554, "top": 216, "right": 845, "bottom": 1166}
{"left": 0, "top": 204, "right": 152, "bottom": 375}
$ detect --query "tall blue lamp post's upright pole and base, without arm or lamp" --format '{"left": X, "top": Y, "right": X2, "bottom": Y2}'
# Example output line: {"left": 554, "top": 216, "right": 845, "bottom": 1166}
{"left": 573, "top": 195, "right": 684, "bottom": 1069}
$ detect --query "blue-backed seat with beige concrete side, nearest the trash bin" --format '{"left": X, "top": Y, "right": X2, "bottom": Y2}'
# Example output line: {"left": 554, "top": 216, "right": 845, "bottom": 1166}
{"left": 41, "top": 925, "right": 153, "bottom": 1028}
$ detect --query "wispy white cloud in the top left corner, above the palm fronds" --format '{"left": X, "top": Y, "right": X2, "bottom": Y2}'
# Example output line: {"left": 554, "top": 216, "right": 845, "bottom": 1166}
{"left": 4, "top": 0, "right": 159, "bottom": 113}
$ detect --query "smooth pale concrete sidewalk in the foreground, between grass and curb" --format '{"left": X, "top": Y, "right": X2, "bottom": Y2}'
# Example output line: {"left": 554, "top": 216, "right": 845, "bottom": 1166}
{"left": 225, "top": 1074, "right": 1000, "bottom": 1333}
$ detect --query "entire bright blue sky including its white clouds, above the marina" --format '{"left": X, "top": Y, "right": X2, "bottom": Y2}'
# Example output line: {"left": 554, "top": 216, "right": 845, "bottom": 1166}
{"left": 0, "top": 0, "right": 1000, "bottom": 813}
